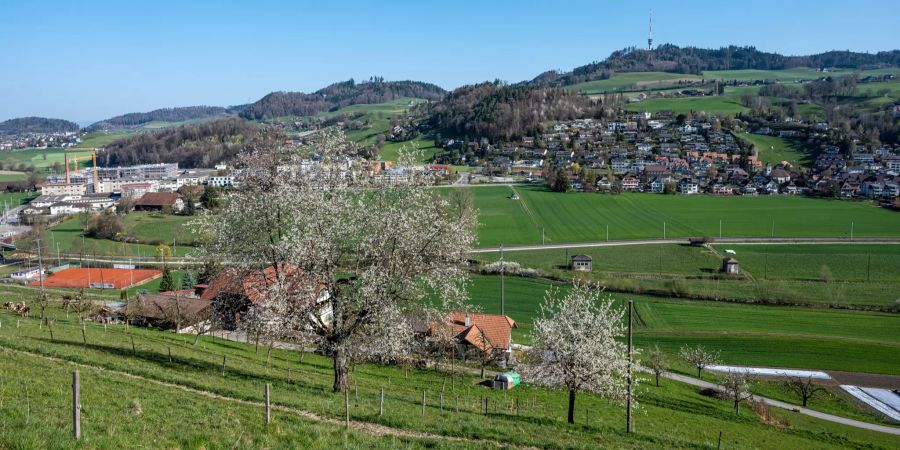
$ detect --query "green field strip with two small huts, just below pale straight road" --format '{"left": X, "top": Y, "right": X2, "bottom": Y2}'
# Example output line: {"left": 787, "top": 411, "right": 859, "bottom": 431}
{"left": 473, "top": 244, "right": 900, "bottom": 309}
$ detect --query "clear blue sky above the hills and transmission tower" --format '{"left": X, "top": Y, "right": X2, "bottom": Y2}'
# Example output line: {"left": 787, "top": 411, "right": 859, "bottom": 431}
{"left": 0, "top": 0, "right": 900, "bottom": 122}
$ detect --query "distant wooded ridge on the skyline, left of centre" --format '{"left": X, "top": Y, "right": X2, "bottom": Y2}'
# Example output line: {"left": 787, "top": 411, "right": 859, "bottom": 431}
{"left": 240, "top": 78, "right": 447, "bottom": 120}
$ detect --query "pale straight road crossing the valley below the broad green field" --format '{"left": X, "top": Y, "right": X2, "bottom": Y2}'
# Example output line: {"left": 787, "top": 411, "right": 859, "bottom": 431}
{"left": 472, "top": 237, "right": 900, "bottom": 253}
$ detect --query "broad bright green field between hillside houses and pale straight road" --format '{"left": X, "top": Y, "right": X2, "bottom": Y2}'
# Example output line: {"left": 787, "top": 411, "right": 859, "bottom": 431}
{"left": 471, "top": 186, "right": 900, "bottom": 246}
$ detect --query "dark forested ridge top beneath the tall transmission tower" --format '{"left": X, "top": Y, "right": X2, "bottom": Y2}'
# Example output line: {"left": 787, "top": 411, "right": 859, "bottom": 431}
{"left": 527, "top": 44, "right": 900, "bottom": 86}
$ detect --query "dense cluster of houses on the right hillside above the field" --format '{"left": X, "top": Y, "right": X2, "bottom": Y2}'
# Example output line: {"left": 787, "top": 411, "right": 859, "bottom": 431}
{"left": 449, "top": 112, "right": 900, "bottom": 197}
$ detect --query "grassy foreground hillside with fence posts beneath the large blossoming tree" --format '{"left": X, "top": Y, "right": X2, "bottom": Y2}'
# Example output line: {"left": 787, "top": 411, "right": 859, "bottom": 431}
{"left": 0, "top": 302, "right": 893, "bottom": 448}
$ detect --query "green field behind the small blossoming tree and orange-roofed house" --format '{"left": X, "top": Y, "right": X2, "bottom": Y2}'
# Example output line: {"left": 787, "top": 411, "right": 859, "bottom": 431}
{"left": 469, "top": 276, "right": 900, "bottom": 374}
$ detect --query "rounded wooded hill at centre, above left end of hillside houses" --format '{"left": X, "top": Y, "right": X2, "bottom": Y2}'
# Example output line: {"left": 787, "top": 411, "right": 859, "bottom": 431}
{"left": 429, "top": 82, "right": 601, "bottom": 141}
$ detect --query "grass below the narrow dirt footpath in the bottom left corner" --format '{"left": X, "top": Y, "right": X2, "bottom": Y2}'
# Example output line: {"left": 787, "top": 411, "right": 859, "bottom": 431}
{"left": 0, "top": 349, "right": 474, "bottom": 449}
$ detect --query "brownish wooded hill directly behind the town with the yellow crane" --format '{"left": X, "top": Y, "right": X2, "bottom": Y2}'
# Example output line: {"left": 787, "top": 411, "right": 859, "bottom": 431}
{"left": 97, "top": 117, "right": 268, "bottom": 168}
